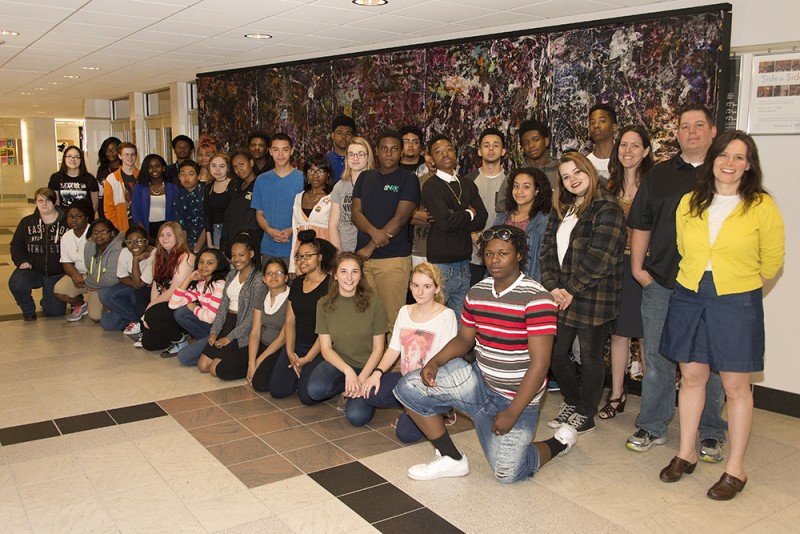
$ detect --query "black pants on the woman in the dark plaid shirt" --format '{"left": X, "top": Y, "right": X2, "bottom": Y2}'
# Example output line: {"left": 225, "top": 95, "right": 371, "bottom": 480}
{"left": 550, "top": 320, "right": 612, "bottom": 417}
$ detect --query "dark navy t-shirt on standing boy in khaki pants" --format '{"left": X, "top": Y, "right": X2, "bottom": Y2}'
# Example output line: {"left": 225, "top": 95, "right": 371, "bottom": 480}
{"left": 353, "top": 168, "right": 420, "bottom": 260}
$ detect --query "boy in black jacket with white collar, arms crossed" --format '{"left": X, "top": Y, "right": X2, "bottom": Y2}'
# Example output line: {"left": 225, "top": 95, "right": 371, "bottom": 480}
{"left": 422, "top": 134, "right": 488, "bottom": 323}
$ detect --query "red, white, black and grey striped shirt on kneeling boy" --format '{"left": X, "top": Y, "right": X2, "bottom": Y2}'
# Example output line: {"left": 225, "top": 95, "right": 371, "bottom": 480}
{"left": 461, "top": 273, "right": 558, "bottom": 404}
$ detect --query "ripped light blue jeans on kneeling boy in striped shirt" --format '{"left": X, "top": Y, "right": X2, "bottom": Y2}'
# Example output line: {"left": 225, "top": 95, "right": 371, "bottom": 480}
{"left": 394, "top": 358, "right": 539, "bottom": 484}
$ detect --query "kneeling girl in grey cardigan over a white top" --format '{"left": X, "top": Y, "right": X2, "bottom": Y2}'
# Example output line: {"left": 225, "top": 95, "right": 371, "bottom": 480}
{"left": 197, "top": 232, "right": 264, "bottom": 380}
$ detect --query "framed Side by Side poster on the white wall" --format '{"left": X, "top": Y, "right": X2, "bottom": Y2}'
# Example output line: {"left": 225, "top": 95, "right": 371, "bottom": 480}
{"left": 747, "top": 52, "right": 800, "bottom": 135}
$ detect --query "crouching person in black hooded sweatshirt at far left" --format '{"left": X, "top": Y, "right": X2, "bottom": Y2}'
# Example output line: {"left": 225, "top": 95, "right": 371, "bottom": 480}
{"left": 8, "top": 187, "right": 67, "bottom": 321}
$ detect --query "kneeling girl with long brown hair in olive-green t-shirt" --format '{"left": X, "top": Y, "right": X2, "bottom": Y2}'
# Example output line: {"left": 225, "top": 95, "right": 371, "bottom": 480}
{"left": 308, "top": 252, "right": 389, "bottom": 426}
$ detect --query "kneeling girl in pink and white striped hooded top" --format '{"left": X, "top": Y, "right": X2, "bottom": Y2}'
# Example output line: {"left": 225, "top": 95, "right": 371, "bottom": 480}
{"left": 166, "top": 249, "right": 231, "bottom": 366}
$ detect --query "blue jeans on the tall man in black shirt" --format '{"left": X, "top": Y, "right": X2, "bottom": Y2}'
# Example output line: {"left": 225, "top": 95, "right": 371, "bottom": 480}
{"left": 636, "top": 282, "right": 728, "bottom": 441}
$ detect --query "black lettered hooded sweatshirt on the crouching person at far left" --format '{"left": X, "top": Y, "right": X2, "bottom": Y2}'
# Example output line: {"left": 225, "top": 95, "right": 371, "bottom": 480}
{"left": 10, "top": 207, "right": 68, "bottom": 276}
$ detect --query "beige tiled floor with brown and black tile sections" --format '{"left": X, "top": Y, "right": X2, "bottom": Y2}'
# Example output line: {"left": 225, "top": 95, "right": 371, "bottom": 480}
{"left": 0, "top": 203, "right": 800, "bottom": 534}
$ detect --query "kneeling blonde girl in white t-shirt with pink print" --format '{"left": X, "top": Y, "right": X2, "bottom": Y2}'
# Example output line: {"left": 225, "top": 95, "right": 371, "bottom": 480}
{"left": 356, "top": 263, "right": 458, "bottom": 443}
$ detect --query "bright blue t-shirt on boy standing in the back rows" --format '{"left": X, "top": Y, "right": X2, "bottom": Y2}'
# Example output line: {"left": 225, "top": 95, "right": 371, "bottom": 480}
{"left": 250, "top": 169, "right": 304, "bottom": 258}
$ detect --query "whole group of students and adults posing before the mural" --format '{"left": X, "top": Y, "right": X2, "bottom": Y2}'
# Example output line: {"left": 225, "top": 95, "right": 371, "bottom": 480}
{"left": 9, "top": 104, "right": 784, "bottom": 499}
